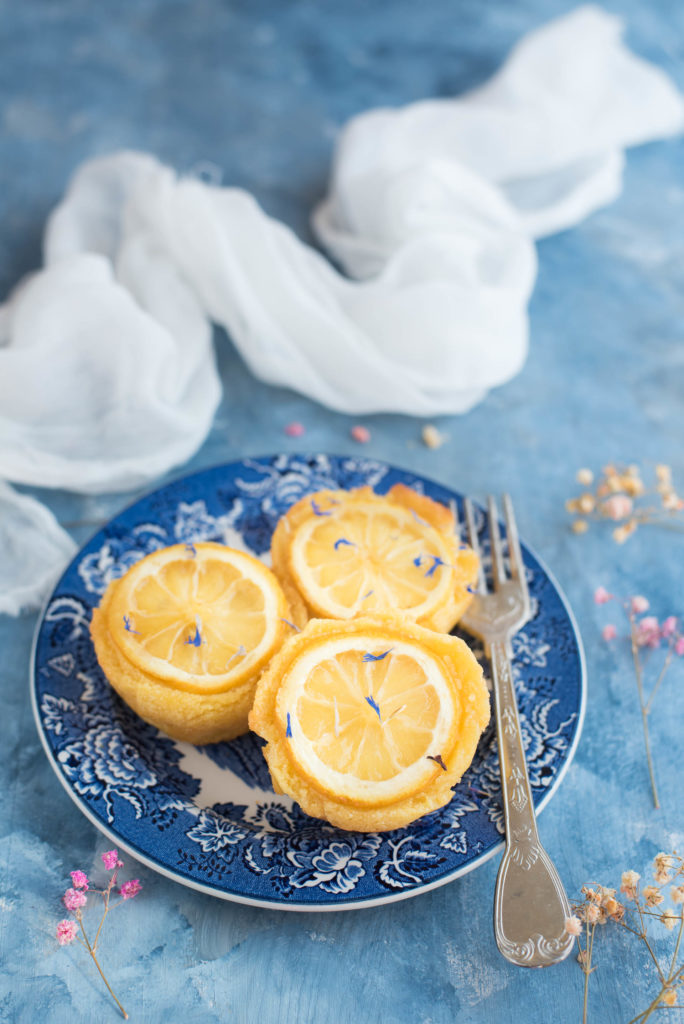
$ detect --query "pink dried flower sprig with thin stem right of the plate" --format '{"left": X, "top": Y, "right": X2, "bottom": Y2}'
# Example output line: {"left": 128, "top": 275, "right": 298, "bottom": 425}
{"left": 594, "top": 587, "right": 684, "bottom": 808}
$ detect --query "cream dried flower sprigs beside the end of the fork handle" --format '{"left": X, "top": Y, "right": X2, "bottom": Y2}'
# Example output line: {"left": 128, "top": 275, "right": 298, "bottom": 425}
{"left": 565, "top": 851, "right": 684, "bottom": 1024}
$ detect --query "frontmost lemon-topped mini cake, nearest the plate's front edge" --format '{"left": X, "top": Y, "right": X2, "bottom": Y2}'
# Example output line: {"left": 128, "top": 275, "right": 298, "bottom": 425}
{"left": 249, "top": 614, "right": 489, "bottom": 831}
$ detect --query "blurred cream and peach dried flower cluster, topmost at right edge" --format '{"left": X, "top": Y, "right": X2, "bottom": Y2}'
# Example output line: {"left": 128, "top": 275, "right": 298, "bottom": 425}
{"left": 565, "top": 463, "right": 684, "bottom": 544}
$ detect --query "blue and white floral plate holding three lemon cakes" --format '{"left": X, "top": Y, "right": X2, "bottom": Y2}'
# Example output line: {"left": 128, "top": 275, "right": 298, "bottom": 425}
{"left": 32, "top": 455, "right": 585, "bottom": 910}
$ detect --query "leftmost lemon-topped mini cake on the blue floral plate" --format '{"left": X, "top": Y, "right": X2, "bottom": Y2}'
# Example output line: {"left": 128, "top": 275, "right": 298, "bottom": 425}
{"left": 91, "top": 542, "right": 291, "bottom": 743}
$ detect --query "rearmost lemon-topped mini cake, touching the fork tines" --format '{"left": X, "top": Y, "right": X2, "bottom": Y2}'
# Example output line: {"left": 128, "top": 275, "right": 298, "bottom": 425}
{"left": 271, "top": 484, "right": 478, "bottom": 632}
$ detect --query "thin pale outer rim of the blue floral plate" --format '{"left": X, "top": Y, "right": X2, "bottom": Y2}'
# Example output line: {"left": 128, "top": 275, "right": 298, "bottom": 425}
{"left": 29, "top": 452, "right": 587, "bottom": 913}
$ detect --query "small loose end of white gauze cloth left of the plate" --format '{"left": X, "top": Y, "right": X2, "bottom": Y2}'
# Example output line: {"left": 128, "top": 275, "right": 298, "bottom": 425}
{"left": 0, "top": 480, "right": 76, "bottom": 615}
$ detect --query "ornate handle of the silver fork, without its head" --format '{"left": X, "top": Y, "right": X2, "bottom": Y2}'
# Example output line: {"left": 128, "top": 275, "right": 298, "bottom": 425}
{"left": 489, "top": 640, "right": 574, "bottom": 967}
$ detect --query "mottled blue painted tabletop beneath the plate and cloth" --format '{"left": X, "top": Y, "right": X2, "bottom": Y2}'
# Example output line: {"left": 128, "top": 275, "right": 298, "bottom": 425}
{"left": 0, "top": 0, "right": 684, "bottom": 1024}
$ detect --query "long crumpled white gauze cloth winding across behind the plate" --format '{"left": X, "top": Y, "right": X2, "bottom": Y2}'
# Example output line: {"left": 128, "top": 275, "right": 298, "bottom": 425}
{"left": 0, "top": 7, "right": 684, "bottom": 614}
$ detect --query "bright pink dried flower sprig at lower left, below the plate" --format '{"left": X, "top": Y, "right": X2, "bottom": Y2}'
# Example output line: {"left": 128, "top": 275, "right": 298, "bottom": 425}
{"left": 56, "top": 850, "right": 142, "bottom": 1020}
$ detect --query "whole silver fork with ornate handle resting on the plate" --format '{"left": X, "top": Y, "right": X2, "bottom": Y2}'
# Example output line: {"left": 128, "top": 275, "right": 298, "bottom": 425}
{"left": 460, "top": 495, "right": 574, "bottom": 967}
